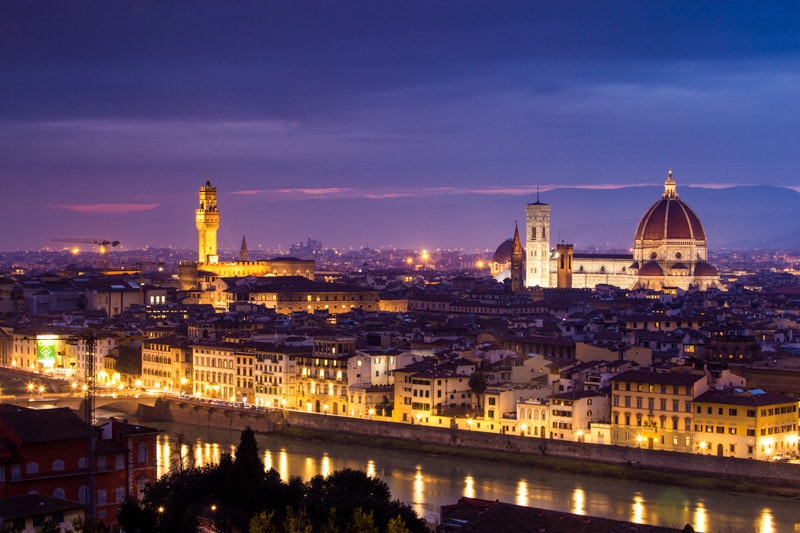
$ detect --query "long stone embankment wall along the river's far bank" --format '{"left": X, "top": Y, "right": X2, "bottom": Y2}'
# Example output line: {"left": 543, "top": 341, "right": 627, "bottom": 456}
{"left": 140, "top": 400, "right": 800, "bottom": 488}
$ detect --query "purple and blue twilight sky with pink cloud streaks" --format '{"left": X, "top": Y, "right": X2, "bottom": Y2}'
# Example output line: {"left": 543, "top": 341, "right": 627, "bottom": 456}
{"left": 0, "top": 0, "right": 800, "bottom": 250}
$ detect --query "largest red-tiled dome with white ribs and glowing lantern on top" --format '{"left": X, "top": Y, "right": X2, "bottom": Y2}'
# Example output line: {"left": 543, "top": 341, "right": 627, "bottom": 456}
{"left": 634, "top": 170, "right": 706, "bottom": 241}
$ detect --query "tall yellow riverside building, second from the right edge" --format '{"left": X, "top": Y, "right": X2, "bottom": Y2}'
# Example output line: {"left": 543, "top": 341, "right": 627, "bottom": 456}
{"left": 611, "top": 370, "right": 708, "bottom": 453}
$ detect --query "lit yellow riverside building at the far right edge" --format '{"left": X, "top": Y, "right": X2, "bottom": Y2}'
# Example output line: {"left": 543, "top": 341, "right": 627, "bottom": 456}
{"left": 694, "top": 388, "right": 798, "bottom": 460}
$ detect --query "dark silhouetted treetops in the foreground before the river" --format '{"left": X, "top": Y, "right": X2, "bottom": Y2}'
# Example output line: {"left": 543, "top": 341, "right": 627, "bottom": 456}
{"left": 137, "top": 429, "right": 426, "bottom": 533}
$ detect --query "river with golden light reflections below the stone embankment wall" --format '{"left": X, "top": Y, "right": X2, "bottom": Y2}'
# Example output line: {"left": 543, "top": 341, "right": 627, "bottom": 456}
{"left": 147, "top": 423, "right": 800, "bottom": 533}
